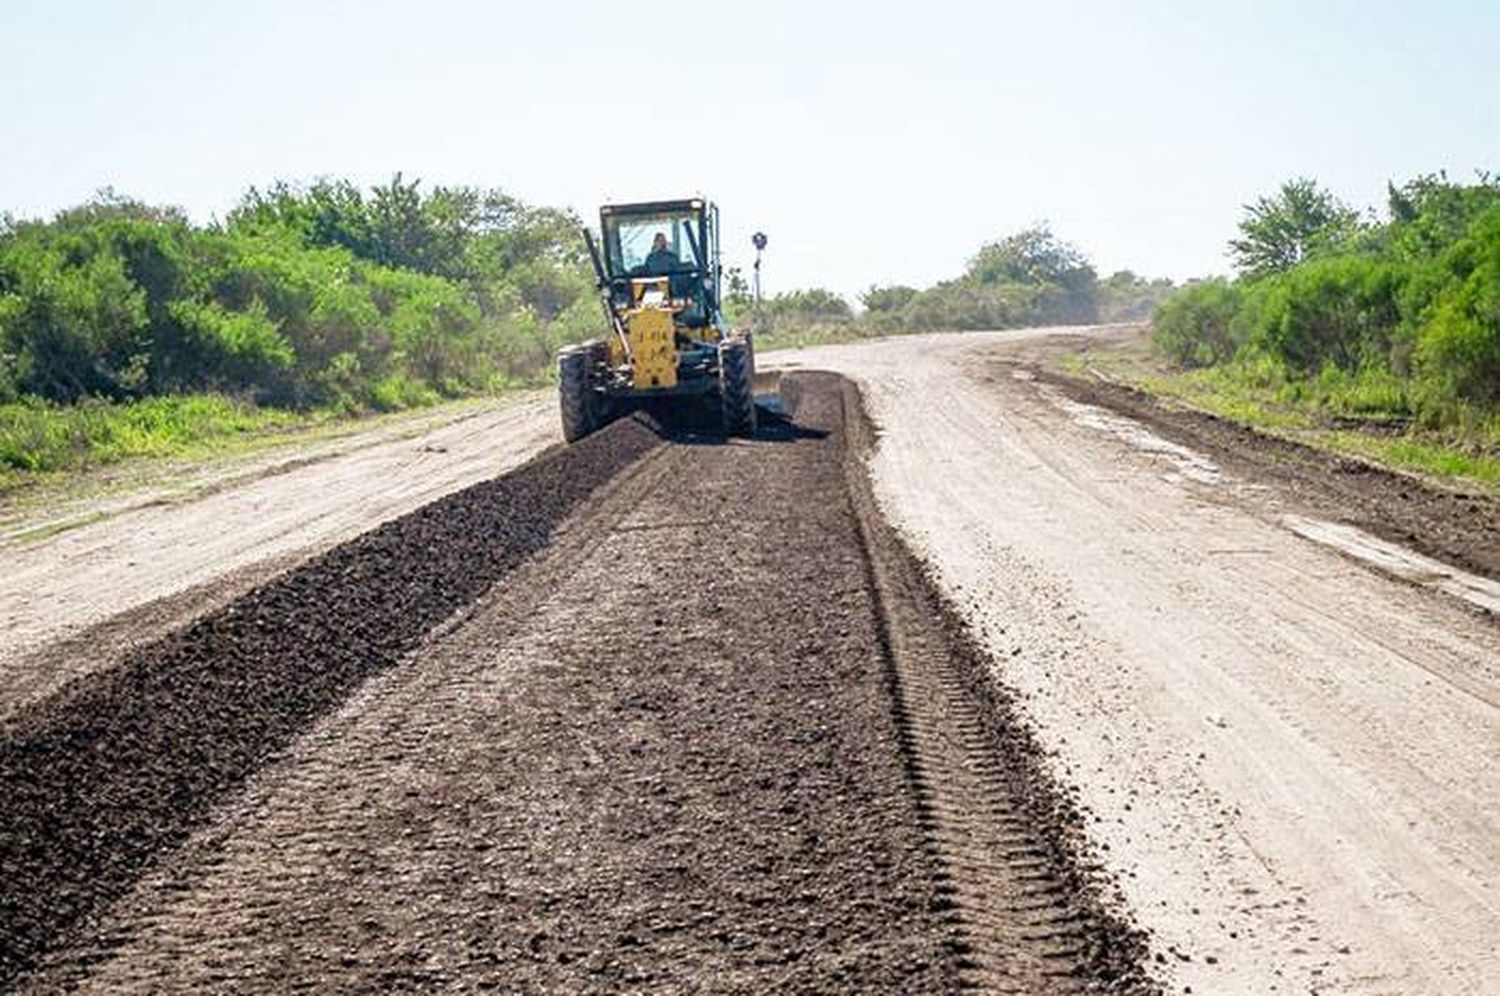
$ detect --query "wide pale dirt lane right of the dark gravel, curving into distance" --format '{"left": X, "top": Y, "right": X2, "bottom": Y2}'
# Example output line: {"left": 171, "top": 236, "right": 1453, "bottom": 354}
{"left": 785, "top": 332, "right": 1500, "bottom": 993}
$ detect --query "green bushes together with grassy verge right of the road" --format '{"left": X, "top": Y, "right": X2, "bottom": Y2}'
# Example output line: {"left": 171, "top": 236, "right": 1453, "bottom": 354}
{"left": 1146, "top": 174, "right": 1500, "bottom": 482}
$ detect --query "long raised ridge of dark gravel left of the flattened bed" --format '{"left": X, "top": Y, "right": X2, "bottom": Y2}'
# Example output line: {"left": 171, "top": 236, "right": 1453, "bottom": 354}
{"left": 0, "top": 419, "right": 659, "bottom": 984}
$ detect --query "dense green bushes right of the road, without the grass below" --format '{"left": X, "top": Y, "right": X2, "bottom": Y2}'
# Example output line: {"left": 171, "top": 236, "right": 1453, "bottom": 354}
{"left": 1154, "top": 176, "right": 1500, "bottom": 425}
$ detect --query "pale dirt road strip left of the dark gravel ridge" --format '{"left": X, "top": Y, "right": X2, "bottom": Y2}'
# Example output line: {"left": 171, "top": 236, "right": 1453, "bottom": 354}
{"left": 0, "top": 395, "right": 563, "bottom": 719}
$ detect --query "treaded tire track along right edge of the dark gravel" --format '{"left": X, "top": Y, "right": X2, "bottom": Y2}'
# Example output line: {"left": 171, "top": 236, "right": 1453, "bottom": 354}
{"left": 843, "top": 375, "right": 1155, "bottom": 993}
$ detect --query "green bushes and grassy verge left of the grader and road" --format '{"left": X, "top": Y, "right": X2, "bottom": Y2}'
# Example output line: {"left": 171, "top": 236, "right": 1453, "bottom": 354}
{"left": 0, "top": 174, "right": 599, "bottom": 486}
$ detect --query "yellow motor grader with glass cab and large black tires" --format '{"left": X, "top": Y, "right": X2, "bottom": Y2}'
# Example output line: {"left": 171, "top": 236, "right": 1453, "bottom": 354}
{"left": 558, "top": 198, "right": 756, "bottom": 443}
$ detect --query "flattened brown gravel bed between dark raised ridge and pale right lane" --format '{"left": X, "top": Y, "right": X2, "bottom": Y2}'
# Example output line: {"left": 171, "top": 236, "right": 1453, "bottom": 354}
{"left": 8, "top": 377, "right": 1145, "bottom": 992}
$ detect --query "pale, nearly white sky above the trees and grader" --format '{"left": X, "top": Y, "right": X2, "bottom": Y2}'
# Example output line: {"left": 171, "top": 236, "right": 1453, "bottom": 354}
{"left": 0, "top": 0, "right": 1500, "bottom": 297}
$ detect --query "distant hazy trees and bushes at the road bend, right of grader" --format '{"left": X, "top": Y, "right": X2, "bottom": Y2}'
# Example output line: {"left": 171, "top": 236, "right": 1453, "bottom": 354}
{"left": 744, "top": 225, "right": 1175, "bottom": 347}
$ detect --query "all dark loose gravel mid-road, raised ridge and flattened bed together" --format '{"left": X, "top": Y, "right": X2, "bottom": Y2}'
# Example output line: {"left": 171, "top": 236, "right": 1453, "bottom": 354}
{"left": 0, "top": 378, "right": 1149, "bottom": 992}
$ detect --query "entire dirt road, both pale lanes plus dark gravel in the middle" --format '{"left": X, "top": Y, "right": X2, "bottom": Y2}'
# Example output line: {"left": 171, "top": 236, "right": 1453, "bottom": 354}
{"left": 0, "top": 330, "right": 1500, "bottom": 993}
